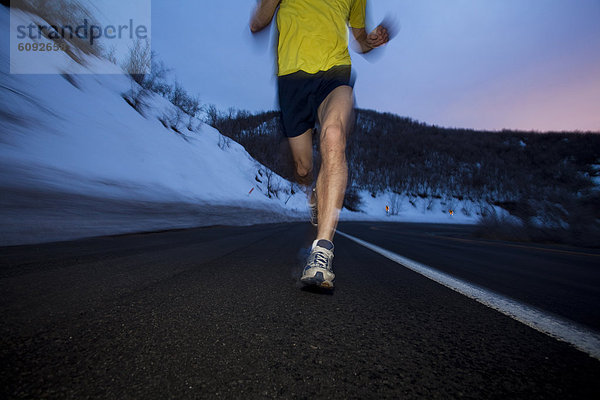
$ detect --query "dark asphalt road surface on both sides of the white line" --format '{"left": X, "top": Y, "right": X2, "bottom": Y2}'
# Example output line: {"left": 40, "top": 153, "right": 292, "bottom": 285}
{"left": 0, "top": 223, "right": 600, "bottom": 399}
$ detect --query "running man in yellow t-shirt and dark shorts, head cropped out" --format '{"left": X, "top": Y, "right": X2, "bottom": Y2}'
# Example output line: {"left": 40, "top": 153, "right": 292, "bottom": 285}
{"left": 250, "top": 0, "right": 389, "bottom": 288}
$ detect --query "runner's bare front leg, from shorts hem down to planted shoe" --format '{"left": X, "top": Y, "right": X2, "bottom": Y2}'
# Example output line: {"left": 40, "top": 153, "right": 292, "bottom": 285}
{"left": 317, "top": 86, "right": 354, "bottom": 241}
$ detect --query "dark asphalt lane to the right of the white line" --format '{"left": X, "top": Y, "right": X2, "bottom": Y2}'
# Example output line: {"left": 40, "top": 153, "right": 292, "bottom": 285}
{"left": 340, "top": 223, "right": 600, "bottom": 332}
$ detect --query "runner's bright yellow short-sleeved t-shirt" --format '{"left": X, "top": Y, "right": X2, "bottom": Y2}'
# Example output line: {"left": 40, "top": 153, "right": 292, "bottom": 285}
{"left": 277, "top": 0, "right": 366, "bottom": 76}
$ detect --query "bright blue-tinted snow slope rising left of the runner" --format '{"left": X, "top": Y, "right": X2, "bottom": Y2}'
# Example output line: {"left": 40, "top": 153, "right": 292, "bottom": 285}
{"left": 0, "top": 6, "right": 314, "bottom": 244}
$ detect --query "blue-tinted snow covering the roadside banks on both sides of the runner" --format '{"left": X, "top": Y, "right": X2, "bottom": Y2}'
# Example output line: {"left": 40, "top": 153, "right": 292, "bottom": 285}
{"left": 0, "top": 6, "right": 492, "bottom": 245}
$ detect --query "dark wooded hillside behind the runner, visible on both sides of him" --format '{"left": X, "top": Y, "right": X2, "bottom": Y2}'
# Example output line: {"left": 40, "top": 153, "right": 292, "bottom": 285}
{"left": 209, "top": 109, "right": 600, "bottom": 247}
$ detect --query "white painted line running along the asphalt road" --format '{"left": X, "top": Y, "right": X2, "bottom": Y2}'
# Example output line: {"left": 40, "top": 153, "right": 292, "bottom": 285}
{"left": 337, "top": 231, "right": 600, "bottom": 360}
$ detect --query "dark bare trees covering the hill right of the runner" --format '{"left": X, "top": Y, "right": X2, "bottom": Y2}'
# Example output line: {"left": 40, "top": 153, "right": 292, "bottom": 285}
{"left": 349, "top": 110, "right": 600, "bottom": 201}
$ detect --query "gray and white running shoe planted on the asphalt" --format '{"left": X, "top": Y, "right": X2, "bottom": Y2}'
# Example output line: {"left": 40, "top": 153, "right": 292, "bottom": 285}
{"left": 300, "top": 239, "right": 335, "bottom": 289}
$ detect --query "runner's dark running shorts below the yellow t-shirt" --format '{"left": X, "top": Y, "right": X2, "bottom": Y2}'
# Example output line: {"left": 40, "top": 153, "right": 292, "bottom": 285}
{"left": 277, "top": 65, "right": 354, "bottom": 137}
